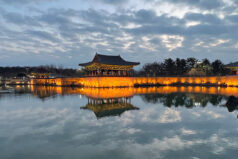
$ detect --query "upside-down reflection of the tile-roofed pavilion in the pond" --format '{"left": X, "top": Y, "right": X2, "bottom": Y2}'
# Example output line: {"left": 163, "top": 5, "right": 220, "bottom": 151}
{"left": 81, "top": 97, "right": 139, "bottom": 118}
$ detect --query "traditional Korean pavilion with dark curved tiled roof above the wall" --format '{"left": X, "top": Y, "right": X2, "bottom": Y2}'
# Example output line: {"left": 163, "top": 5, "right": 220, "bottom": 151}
{"left": 79, "top": 53, "right": 140, "bottom": 76}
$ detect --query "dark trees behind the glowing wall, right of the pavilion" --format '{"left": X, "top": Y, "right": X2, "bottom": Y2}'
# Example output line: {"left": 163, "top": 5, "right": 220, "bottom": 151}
{"left": 136, "top": 58, "right": 229, "bottom": 76}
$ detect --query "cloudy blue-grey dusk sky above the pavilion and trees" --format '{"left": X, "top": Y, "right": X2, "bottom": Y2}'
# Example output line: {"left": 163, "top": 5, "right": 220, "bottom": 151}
{"left": 0, "top": 0, "right": 238, "bottom": 68}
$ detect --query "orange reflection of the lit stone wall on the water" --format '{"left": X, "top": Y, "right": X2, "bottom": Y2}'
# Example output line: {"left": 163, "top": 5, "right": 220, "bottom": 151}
{"left": 31, "top": 86, "right": 238, "bottom": 99}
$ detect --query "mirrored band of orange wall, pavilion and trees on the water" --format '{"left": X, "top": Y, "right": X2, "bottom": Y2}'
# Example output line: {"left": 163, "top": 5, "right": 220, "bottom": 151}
{"left": 0, "top": 86, "right": 238, "bottom": 114}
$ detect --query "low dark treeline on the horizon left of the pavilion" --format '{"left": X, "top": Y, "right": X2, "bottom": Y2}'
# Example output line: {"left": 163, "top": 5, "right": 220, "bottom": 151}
{"left": 0, "top": 65, "right": 84, "bottom": 77}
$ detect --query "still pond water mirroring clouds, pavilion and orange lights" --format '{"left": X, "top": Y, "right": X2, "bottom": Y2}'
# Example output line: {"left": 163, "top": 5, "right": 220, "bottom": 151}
{"left": 0, "top": 87, "right": 238, "bottom": 159}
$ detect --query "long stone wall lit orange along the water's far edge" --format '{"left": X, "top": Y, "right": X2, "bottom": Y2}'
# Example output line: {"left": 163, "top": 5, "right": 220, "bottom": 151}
{"left": 31, "top": 76, "right": 238, "bottom": 87}
